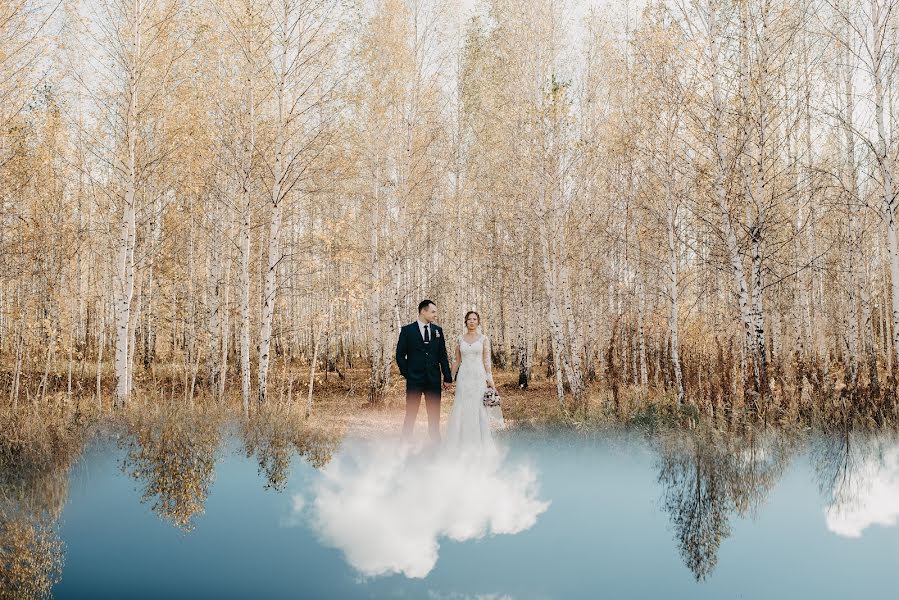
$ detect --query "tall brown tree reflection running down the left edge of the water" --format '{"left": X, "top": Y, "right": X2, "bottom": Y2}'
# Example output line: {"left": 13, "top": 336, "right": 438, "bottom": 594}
{"left": 0, "top": 415, "right": 85, "bottom": 599}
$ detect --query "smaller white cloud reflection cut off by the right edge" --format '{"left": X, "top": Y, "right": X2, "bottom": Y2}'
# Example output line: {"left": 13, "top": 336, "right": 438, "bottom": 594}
{"left": 825, "top": 446, "right": 899, "bottom": 538}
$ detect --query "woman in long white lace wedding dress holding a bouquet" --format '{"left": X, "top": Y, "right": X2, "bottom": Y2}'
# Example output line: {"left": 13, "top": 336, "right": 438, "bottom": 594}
{"left": 444, "top": 310, "right": 504, "bottom": 452}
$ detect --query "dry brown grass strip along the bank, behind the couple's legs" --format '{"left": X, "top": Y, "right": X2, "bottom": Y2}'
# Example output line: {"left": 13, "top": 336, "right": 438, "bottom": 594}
{"left": 0, "top": 348, "right": 897, "bottom": 442}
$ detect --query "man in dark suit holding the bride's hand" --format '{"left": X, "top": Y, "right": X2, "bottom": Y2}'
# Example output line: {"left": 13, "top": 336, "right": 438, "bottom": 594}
{"left": 396, "top": 300, "right": 453, "bottom": 443}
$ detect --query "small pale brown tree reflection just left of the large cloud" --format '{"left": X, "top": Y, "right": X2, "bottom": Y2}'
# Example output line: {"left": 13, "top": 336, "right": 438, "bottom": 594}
{"left": 240, "top": 409, "right": 342, "bottom": 490}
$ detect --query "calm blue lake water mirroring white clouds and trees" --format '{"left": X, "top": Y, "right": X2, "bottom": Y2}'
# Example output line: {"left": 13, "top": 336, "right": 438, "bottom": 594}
{"left": 12, "top": 424, "right": 899, "bottom": 599}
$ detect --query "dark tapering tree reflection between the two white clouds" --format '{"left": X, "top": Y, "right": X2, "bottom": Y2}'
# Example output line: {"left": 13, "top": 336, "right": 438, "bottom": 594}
{"left": 657, "top": 430, "right": 792, "bottom": 580}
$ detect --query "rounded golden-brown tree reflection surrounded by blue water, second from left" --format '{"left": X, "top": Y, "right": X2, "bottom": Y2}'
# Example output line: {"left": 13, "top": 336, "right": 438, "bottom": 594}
{"left": 123, "top": 409, "right": 222, "bottom": 531}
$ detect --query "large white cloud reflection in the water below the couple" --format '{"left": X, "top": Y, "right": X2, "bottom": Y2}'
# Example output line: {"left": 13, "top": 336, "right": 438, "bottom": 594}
{"left": 291, "top": 438, "right": 549, "bottom": 577}
